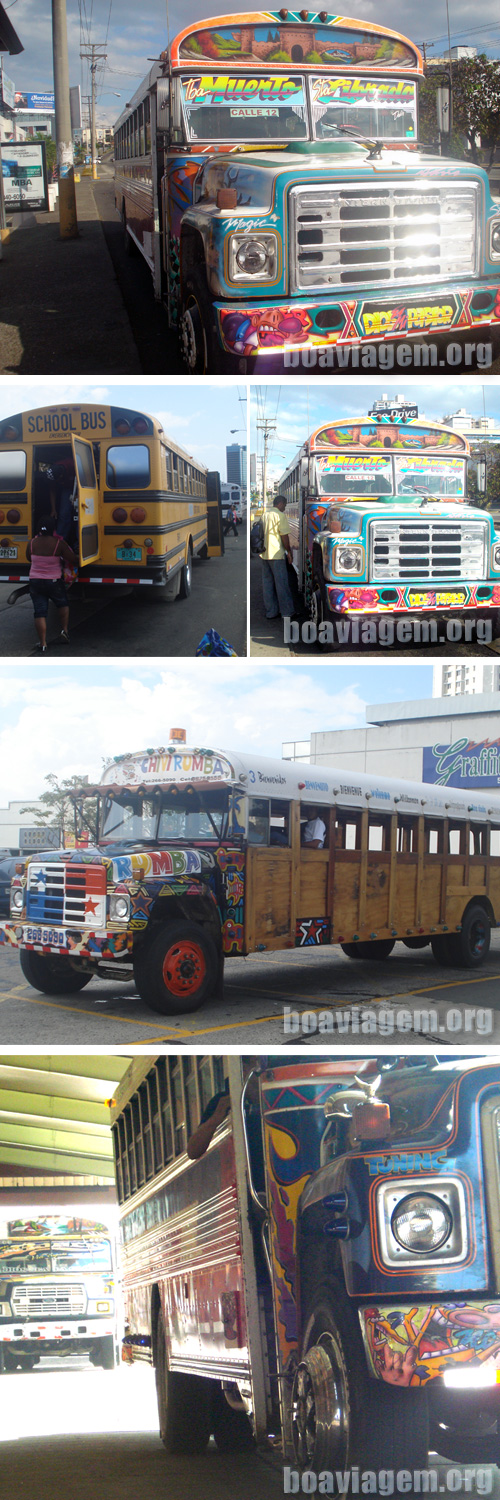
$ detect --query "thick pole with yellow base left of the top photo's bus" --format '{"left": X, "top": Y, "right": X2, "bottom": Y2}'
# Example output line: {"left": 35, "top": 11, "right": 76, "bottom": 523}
{"left": 53, "top": 0, "right": 78, "bottom": 240}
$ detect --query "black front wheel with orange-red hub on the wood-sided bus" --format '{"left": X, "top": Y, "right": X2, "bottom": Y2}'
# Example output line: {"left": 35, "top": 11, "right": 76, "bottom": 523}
{"left": 134, "top": 918, "right": 219, "bottom": 1016}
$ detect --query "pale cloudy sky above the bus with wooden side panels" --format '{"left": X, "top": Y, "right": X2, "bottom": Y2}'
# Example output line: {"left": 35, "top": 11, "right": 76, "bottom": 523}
{"left": 0, "top": 660, "right": 432, "bottom": 809}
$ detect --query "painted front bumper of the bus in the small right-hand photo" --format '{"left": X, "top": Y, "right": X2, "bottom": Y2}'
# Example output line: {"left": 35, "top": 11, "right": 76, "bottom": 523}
{"left": 326, "top": 579, "right": 500, "bottom": 615}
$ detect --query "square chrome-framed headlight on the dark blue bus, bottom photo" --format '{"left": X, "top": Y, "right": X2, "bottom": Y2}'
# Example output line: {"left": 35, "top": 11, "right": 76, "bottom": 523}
{"left": 377, "top": 1173, "right": 468, "bottom": 1269}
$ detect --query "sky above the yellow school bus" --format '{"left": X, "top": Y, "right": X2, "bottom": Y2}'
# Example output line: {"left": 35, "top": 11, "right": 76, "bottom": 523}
{"left": 0, "top": 381, "right": 246, "bottom": 480}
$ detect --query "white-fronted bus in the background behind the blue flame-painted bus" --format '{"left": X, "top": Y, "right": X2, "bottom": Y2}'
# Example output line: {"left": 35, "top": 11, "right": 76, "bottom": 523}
{"left": 0, "top": 1205, "right": 117, "bottom": 1374}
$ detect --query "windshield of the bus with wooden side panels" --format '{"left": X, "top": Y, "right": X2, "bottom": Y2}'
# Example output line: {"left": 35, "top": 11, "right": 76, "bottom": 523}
{"left": 99, "top": 786, "right": 230, "bottom": 843}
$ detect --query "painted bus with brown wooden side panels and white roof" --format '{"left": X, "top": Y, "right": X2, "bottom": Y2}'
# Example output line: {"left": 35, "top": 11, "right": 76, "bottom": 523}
{"left": 0, "top": 743, "right": 500, "bottom": 1014}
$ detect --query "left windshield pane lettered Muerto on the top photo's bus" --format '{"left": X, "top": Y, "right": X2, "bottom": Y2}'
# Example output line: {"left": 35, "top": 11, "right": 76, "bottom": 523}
{"left": 180, "top": 74, "right": 308, "bottom": 143}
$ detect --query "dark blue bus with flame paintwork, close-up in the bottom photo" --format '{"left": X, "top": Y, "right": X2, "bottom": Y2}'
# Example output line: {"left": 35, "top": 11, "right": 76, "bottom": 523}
{"left": 113, "top": 1056, "right": 500, "bottom": 1476}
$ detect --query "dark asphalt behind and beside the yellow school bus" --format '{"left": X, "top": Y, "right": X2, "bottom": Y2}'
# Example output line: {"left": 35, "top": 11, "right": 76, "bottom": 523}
{"left": 0, "top": 524, "right": 246, "bottom": 659}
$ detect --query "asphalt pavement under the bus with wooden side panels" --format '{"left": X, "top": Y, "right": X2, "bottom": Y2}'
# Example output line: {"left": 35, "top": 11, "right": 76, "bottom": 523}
{"left": 0, "top": 932, "right": 500, "bottom": 1052}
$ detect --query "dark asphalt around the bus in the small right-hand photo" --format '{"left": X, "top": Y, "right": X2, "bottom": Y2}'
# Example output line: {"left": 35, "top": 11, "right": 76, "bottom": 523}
{"left": 249, "top": 557, "right": 500, "bottom": 662}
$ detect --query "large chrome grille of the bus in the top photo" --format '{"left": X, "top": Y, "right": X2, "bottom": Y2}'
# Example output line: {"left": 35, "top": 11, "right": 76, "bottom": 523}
{"left": 290, "top": 180, "right": 479, "bottom": 291}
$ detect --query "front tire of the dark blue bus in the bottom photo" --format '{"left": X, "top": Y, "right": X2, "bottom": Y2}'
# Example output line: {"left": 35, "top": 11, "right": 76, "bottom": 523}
{"left": 291, "top": 1281, "right": 429, "bottom": 1473}
